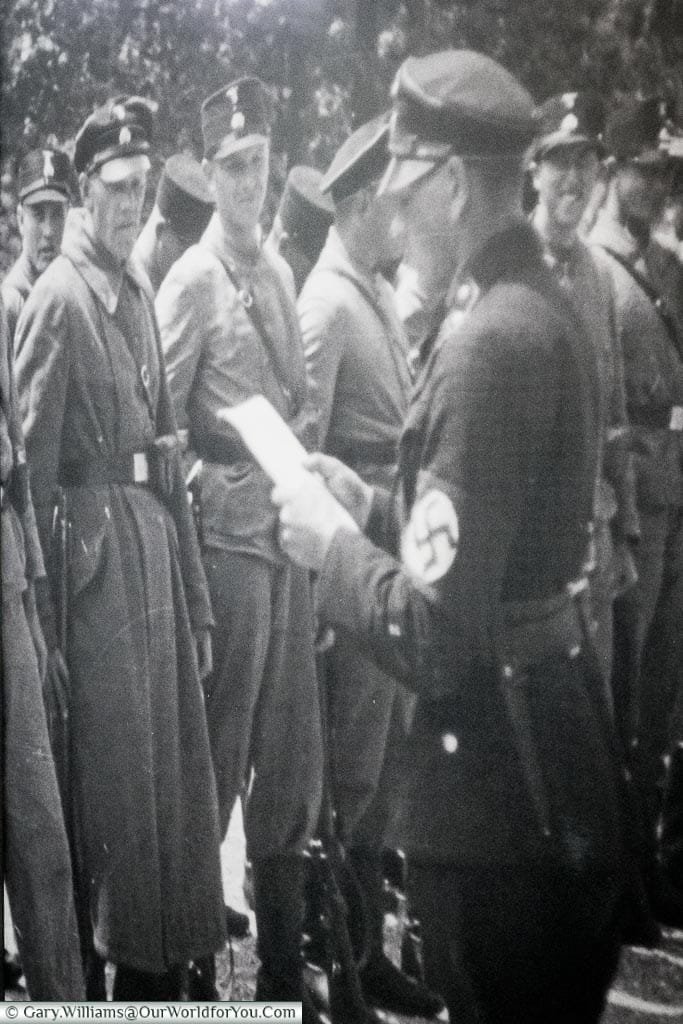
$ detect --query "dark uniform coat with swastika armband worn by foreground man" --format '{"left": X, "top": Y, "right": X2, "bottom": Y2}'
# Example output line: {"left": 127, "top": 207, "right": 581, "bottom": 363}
{"left": 317, "top": 223, "right": 602, "bottom": 865}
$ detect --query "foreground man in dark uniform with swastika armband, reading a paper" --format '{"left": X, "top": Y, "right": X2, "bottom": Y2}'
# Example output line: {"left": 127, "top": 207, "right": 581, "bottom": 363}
{"left": 273, "top": 50, "right": 622, "bottom": 1024}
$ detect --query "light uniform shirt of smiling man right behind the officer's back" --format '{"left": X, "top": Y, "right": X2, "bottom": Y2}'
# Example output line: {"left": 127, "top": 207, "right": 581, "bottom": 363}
{"left": 532, "top": 227, "right": 638, "bottom": 537}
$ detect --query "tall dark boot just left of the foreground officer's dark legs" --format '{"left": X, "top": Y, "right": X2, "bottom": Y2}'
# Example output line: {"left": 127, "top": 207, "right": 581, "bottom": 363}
{"left": 348, "top": 846, "right": 445, "bottom": 1018}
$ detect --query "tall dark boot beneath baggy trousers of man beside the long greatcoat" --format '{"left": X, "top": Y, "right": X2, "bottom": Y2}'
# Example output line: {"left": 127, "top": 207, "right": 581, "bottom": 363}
{"left": 253, "top": 854, "right": 322, "bottom": 1024}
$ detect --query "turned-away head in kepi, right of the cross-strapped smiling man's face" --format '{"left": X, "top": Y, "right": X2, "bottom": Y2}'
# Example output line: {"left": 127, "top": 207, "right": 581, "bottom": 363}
{"left": 265, "top": 164, "right": 335, "bottom": 295}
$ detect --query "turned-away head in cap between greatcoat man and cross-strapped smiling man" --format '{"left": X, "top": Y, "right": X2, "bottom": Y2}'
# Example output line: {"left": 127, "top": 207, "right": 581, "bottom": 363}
{"left": 133, "top": 153, "right": 214, "bottom": 295}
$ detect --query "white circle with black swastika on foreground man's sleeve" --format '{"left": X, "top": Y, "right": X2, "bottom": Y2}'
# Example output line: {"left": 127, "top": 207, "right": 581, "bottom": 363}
{"left": 400, "top": 487, "right": 460, "bottom": 584}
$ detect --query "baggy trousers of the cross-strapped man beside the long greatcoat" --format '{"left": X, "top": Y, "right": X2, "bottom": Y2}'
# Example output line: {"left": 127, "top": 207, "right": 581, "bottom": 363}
{"left": 204, "top": 548, "right": 323, "bottom": 858}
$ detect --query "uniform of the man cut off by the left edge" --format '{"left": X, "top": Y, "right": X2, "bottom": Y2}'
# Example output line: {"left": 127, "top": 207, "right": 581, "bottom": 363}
{"left": 0, "top": 303, "right": 84, "bottom": 1000}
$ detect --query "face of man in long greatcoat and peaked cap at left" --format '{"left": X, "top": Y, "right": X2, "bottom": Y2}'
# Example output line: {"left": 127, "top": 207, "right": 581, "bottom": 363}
{"left": 82, "top": 171, "right": 147, "bottom": 263}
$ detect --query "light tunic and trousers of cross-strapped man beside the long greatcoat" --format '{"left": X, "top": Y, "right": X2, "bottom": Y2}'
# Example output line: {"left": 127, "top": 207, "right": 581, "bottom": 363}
{"left": 156, "top": 215, "right": 322, "bottom": 857}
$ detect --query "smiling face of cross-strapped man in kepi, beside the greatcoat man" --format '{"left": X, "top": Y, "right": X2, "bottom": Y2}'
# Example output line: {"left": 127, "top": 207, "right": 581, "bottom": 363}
{"left": 208, "top": 139, "right": 269, "bottom": 233}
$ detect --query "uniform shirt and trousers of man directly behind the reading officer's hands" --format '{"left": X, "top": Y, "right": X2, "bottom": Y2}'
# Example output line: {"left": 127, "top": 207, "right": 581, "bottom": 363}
{"left": 298, "top": 227, "right": 412, "bottom": 845}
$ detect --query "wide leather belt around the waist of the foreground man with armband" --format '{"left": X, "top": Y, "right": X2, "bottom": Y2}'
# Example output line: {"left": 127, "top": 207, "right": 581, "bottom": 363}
{"left": 498, "top": 588, "right": 584, "bottom": 678}
